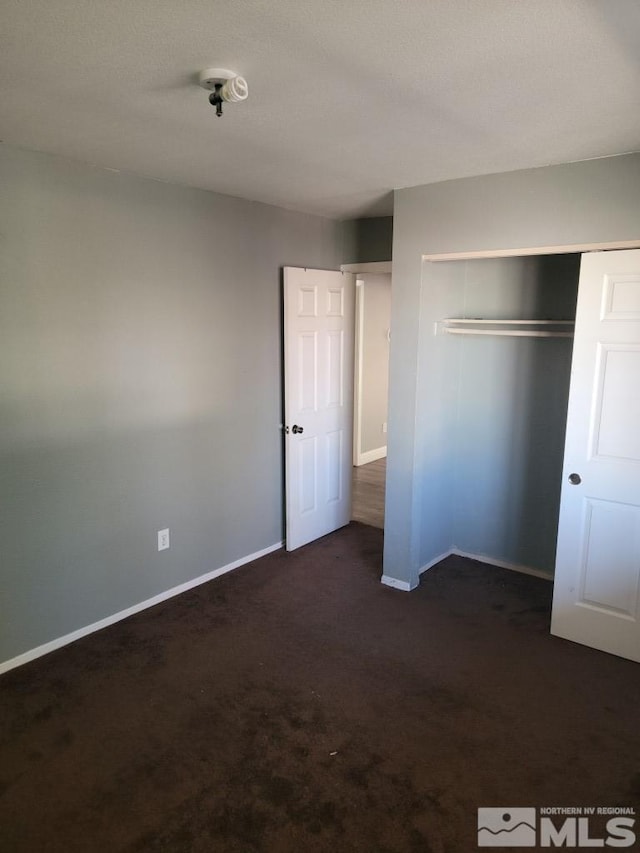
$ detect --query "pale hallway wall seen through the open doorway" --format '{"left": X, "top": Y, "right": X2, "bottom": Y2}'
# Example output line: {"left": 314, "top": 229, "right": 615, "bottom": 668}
{"left": 358, "top": 273, "right": 391, "bottom": 453}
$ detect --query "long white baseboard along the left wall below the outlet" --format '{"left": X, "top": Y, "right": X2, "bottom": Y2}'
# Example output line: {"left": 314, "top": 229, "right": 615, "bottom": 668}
{"left": 0, "top": 542, "right": 284, "bottom": 675}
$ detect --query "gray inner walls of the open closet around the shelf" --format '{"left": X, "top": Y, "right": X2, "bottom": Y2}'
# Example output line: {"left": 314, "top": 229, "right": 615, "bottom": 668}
{"left": 419, "top": 250, "right": 580, "bottom": 574}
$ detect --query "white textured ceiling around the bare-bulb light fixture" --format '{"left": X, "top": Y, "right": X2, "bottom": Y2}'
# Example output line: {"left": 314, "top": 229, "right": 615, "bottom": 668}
{"left": 0, "top": 0, "right": 640, "bottom": 218}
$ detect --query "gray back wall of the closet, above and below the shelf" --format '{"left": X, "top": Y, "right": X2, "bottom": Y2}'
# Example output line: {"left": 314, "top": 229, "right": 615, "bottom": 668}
{"left": 448, "top": 255, "right": 580, "bottom": 574}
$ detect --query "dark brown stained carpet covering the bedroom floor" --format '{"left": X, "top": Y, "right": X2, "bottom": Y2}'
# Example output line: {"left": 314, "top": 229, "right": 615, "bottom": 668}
{"left": 0, "top": 524, "right": 640, "bottom": 853}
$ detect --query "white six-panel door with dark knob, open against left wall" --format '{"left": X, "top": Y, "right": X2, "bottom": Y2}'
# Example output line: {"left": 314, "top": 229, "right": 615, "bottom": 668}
{"left": 284, "top": 267, "right": 355, "bottom": 551}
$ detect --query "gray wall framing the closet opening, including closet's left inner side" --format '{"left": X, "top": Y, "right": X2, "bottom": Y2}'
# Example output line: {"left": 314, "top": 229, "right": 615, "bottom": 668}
{"left": 384, "top": 154, "right": 640, "bottom": 587}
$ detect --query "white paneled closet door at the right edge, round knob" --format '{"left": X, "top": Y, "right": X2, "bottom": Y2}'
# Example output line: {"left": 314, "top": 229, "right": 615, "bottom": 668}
{"left": 551, "top": 249, "right": 640, "bottom": 661}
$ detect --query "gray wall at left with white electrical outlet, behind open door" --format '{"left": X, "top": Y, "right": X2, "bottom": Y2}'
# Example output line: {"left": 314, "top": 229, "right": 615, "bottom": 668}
{"left": 0, "top": 146, "right": 343, "bottom": 661}
